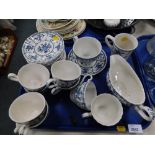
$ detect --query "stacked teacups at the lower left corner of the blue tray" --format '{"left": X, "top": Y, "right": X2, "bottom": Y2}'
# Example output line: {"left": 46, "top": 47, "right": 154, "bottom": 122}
{"left": 9, "top": 92, "right": 47, "bottom": 133}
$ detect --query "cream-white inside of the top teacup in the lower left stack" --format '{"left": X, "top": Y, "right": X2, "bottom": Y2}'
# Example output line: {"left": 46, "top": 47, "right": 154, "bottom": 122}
{"left": 9, "top": 92, "right": 46, "bottom": 123}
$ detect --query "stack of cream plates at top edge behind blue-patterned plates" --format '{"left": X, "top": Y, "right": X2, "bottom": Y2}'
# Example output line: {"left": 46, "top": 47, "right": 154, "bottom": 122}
{"left": 36, "top": 19, "right": 86, "bottom": 40}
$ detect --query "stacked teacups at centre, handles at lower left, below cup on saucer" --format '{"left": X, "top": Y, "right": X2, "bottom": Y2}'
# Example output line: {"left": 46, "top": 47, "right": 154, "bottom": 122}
{"left": 49, "top": 60, "right": 81, "bottom": 95}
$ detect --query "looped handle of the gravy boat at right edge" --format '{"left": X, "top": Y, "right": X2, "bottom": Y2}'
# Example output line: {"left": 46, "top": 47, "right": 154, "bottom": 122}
{"left": 135, "top": 105, "right": 155, "bottom": 121}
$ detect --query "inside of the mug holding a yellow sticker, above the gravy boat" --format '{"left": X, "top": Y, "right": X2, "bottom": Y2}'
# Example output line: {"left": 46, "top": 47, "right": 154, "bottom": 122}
{"left": 115, "top": 33, "right": 138, "bottom": 51}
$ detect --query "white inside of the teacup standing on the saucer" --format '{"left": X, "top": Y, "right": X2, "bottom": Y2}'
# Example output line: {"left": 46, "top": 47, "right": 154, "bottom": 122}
{"left": 73, "top": 37, "right": 102, "bottom": 59}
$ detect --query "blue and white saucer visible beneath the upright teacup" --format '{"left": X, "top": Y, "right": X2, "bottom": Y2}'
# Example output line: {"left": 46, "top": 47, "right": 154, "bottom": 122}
{"left": 68, "top": 50, "right": 107, "bottom": 75}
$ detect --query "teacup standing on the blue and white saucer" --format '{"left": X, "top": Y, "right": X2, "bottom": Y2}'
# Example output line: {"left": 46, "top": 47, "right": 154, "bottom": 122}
{"left": 73, "top": 37, "right": 102, "bottom": 67}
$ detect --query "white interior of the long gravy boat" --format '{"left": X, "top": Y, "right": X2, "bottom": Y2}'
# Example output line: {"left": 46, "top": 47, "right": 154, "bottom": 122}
{"left": 109, "top": 55, "right": 145, "bottom": 105}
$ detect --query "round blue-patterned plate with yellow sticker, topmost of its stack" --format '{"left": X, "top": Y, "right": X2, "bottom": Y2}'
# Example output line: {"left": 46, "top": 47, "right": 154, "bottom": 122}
{"left": 22, "top": 31, "right": 64, "bottom": 65}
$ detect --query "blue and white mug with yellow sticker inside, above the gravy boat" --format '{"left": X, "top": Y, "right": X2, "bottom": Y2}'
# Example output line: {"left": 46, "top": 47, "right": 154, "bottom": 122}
{"left": 105, "top": 33, "right": 138, "bottom": 59}
